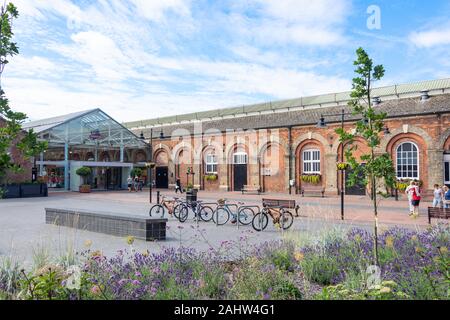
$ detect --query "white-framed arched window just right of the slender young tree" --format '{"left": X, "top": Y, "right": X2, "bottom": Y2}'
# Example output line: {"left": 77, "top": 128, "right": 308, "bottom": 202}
{"left": 397, "top": 142, "right": 419, "bottom": 179}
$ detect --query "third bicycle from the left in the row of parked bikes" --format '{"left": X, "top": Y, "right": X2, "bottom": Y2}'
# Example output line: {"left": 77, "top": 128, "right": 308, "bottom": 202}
{"left": 212, "top": 199, "right": 255, "bottom": 226}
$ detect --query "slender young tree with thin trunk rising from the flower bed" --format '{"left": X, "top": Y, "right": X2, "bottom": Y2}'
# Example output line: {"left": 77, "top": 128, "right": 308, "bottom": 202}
{"left": 336, "top": 48, "right": 396, "bottom": 265}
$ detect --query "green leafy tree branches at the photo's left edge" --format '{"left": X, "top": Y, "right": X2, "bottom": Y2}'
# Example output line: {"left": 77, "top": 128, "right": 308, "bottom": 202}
{"left": 0, "top": 3, "right": 47, "bottom": 186}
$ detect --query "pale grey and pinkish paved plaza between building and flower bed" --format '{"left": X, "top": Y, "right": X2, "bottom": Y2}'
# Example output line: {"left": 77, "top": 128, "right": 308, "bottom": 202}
{"left": 0, "top": 190, "right": 436, "bottom": 263}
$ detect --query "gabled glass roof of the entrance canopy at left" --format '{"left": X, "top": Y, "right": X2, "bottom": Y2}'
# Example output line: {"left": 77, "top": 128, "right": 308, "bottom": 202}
{"left": 23, "top": 109, "right": 149, "bottom": 149}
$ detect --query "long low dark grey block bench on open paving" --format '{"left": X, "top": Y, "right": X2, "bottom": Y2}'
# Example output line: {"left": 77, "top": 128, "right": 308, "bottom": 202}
{"left": 45, "top": 208, "right": 167, "bottom": 241}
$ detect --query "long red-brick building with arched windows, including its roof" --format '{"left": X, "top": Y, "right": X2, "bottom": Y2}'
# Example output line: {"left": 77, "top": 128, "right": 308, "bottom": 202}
{"left": 125, "top": 79, "right": 450, "bottom": 194}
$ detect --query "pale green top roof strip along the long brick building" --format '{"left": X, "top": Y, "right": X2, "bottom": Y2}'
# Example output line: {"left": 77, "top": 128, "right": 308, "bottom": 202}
{"left": 124, "top": 78, "right": 450, "bottom": 128}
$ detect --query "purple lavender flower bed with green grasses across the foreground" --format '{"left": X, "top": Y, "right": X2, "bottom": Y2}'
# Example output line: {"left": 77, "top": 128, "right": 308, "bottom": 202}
{"left": 0, "top": 224, "right": 450, "bottom": 300}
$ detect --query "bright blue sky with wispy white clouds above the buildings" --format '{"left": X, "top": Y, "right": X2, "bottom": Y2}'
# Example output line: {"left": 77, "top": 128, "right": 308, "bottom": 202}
{"left": 2, "top": 0, "right": 450, "bottom": 122}
